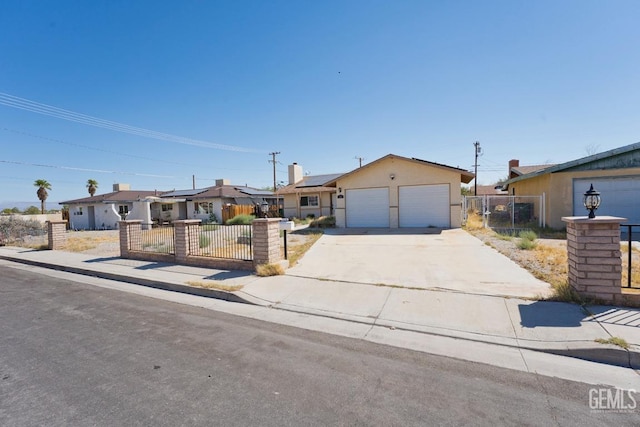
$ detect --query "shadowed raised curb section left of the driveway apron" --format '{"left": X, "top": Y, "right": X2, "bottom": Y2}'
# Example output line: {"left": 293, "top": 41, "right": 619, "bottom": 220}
{"left": 0, "top": 255, "right": 252, "bottom": 305}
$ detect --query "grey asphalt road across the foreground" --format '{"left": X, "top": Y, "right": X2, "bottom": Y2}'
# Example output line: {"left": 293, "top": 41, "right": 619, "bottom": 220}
{"left": 0, "top": 266, "right": 640, "bottom": 426}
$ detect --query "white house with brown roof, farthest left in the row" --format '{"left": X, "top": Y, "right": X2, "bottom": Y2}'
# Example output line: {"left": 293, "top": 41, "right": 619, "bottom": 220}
{"left": 60, "top": 184, "right": 164, "bottom": 230}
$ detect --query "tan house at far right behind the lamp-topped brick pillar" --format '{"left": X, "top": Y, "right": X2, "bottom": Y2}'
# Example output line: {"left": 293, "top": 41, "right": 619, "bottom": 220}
{"left": 503, "top": 143, "right": 640, "bottom": 229}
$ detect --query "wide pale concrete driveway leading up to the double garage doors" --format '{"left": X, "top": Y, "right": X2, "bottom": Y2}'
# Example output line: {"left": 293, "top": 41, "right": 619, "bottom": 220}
{"left": 286, "top": 229, "right": 551, "bottom": 297}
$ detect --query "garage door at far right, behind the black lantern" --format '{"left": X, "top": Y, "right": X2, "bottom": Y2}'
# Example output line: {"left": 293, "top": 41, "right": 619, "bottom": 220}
{"left": 573, "top": 177, "right": 640, "bottom": 224}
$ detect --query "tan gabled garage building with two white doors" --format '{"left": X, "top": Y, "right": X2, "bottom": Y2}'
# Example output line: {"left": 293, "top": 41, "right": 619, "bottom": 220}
{"left": 324, "top": 154, "right": 474, "bottom": 228}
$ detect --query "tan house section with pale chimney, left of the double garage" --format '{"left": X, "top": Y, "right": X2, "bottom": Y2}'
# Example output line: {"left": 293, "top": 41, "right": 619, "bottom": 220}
{"left": 276, "top": 163, "right": 342, "bottom": 218}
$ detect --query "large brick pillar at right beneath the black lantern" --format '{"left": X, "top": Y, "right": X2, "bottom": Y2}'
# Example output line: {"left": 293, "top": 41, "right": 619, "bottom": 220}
{"left": 562, "top": 216, "right": 626, "bottom": 303}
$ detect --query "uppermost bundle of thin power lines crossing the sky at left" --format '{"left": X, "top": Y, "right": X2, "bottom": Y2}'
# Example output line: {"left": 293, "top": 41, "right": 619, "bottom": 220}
{"left": 0, "top": 92, "right": 263, "bottom": 153}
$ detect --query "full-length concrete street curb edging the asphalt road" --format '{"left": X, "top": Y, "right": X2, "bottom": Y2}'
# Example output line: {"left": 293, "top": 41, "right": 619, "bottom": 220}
{"left": 0, "top": 255, "right": 640, "bottom": 370}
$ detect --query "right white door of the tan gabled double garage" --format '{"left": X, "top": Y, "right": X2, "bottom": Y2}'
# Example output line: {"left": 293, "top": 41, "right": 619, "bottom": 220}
{"left": 398, "top": 184, "right": 451, "bottom": 228}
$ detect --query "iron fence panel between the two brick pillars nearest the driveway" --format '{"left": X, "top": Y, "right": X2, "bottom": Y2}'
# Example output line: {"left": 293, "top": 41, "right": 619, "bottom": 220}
{"left": 189, "top": 224, "right": 253, "bottom": 261}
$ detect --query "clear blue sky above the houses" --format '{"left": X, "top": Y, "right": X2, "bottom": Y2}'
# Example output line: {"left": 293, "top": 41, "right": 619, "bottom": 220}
{"left": 0, "top": 0, "right": 640, "bottom": 208}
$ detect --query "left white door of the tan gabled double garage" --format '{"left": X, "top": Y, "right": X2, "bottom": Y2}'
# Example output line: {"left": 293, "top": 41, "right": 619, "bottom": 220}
{"left": 345, "top": 188, "right": 389, "bottom": 228}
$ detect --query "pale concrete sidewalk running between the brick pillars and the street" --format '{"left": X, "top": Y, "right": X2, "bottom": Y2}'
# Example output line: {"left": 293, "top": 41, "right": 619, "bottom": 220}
{"left": 0, "top": 247, "right": 640, "bottom": 370}
